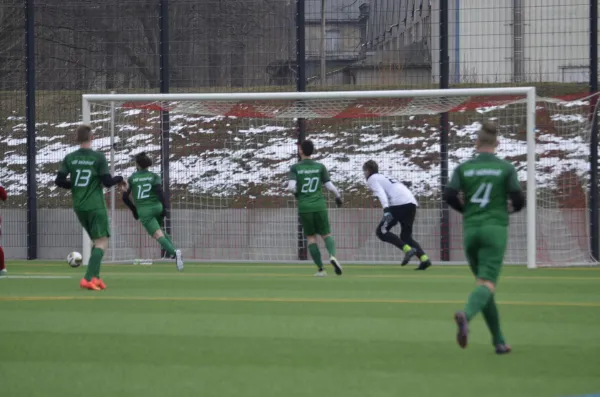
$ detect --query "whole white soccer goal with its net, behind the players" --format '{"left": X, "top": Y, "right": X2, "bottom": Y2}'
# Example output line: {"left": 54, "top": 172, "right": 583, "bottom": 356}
{"left": 78, "top": 87, "right": 591, "bottom": 268}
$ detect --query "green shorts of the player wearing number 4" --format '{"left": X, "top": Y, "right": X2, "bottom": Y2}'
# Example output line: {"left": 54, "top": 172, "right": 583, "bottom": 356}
{"left": 463, "top": 225, "right": 508, "bottom": 284}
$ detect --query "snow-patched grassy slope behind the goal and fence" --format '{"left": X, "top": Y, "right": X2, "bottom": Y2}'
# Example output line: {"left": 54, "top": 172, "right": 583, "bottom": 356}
{"left": 0, "top": 101, "right": 589, "bottom": 197}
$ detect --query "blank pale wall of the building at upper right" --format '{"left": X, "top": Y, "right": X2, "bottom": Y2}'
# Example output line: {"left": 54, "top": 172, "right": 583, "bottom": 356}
{"left": 449, "top": 0, "right": 589, "bottom": 83}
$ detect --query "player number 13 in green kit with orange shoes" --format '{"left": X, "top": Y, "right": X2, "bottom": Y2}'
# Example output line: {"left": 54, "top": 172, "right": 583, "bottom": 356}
{"left": 55, "top": 125, "right": 124, "bottom": 291}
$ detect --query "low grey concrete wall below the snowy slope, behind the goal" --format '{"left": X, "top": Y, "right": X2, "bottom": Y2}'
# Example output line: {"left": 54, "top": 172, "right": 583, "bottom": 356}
{"left": 2, "top": 209, "right": 588, "bottom": 263}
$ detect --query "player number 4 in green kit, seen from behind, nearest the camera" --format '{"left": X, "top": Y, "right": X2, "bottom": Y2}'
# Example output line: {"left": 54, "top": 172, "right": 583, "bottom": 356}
{"left": 444, "top": 123, "right": 525, "bottom": 354}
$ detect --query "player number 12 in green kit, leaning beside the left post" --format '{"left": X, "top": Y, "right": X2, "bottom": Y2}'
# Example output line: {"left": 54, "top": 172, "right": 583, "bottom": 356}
{"left": 123, "top": 153, "right": 183, "bottom": 271}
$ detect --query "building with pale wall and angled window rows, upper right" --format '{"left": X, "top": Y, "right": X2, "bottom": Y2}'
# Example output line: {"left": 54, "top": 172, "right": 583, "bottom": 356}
{"left": 354, "top": 0, "right": 589, "bottom": 84}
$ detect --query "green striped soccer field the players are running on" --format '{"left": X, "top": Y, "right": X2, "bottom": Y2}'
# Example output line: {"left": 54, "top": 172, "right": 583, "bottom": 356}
{"left": 0, "top": 262, "right": 600, "bottom": 397}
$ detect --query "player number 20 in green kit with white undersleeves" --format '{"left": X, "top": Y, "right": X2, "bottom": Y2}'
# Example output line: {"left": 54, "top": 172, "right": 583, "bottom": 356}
{"left": 288, "top": 141, "right": 342, "bottom": 277}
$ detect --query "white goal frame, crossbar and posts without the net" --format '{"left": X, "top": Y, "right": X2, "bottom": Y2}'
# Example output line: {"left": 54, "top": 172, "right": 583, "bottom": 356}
{"left": 82, "top": 87, "right": 536, "bottom": 268}
